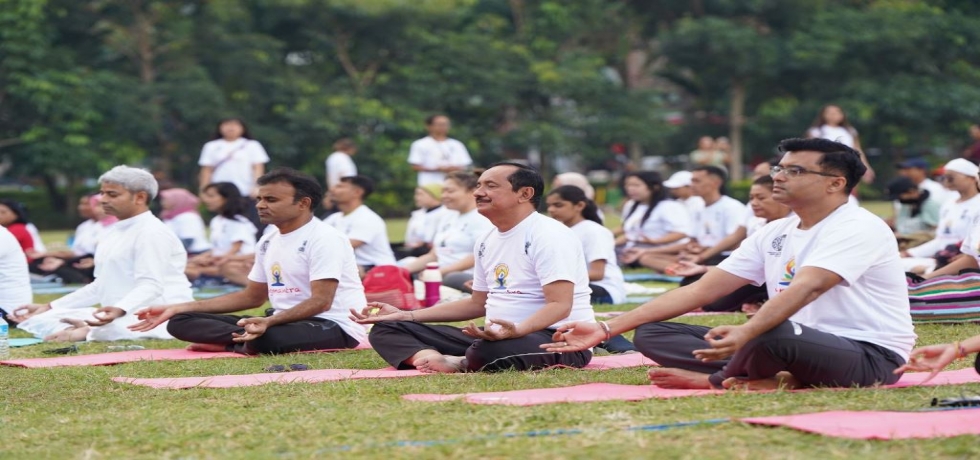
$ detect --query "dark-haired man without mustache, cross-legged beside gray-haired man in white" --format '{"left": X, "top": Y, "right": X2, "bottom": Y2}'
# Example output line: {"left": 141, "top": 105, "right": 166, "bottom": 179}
{"left": 131, "top": 168, "right": 367, "bottom": 354}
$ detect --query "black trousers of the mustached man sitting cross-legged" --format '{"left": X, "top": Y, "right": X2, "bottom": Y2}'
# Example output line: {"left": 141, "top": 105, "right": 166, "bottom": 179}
{"left": 368, "top": 321, "right": 592, "bottom": 372}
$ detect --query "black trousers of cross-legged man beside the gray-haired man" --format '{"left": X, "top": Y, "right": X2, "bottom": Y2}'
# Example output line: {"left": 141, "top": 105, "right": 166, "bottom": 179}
{"left": 167, "top": 313, "right": 358, "bottom": 355}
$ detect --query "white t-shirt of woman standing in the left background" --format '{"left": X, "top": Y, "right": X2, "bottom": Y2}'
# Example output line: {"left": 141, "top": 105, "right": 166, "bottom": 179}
{"left": 197, "top": 137, "right": 269, "bottom": 196}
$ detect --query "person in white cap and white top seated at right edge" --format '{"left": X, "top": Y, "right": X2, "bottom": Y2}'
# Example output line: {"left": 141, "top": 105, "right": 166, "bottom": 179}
{"left": 901, "top": 158, "right": 980, "bottom": 275}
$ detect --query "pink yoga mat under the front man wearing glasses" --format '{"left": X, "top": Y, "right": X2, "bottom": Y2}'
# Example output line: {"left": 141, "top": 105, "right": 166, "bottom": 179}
{"left": 403, "top": 369, "right": 980, "bottom": 406}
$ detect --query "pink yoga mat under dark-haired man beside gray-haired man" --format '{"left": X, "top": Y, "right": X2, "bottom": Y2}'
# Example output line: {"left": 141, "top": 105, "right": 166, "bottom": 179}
{"left": 0, "top": 344, "right": 371, "bottom": 368}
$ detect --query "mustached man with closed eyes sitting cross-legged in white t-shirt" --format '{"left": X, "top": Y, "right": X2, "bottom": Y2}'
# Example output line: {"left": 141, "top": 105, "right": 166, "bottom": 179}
{"left": 351, "top": 163, "right": 595, "bottom": 373}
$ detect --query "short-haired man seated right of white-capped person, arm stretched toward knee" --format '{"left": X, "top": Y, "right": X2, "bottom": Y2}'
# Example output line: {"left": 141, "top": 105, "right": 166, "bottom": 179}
{"left": 639, "top": 166, "right": 748, "bottom": 270}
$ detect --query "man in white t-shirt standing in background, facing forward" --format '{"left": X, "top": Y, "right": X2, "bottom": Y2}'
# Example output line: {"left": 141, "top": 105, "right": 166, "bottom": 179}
{"left": 408, "top": 115, "right": 473, "bottom": 186}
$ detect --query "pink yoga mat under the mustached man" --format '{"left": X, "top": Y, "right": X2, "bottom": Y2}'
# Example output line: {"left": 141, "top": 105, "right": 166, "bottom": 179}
{"left": 112, "top": 353, "right": 654, "bottom": 389}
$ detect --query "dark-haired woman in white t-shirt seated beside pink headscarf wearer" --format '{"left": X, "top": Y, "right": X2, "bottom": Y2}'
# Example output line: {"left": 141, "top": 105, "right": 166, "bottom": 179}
{"left": 184, "top": 182, "right": 256, "bottom": 281}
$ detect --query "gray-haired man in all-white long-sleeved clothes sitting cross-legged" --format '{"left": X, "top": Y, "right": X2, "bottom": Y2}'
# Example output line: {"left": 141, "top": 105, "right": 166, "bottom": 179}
{"left": 10, "top": 166, "right": 193, "bottom": 342}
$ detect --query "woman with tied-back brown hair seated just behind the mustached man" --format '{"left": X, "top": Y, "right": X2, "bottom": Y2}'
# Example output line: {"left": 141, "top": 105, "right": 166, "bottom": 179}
{"left": 403, "top": 171, "right": 493, "bottom": 292}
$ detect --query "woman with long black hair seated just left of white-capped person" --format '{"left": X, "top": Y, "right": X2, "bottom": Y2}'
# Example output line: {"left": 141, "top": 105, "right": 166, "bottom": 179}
{"left": 616, "top": 171, "right": 694, "bottom": 267}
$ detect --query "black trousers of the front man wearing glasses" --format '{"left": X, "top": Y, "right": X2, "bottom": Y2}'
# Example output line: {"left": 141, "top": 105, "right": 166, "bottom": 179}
{"left": 633, "top": 321, "right": 905, "bottom": 388}
